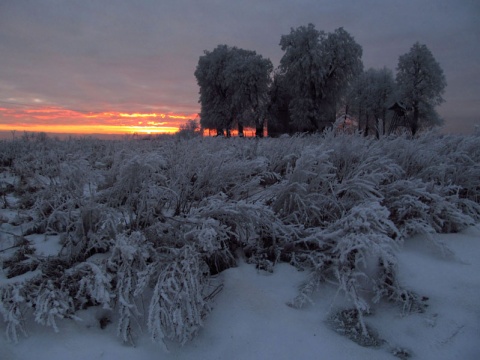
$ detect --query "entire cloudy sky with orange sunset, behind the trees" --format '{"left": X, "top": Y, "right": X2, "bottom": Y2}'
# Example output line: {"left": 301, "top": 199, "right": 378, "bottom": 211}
{"left": 0, "top": 0, "right": 480, "bottom": 133}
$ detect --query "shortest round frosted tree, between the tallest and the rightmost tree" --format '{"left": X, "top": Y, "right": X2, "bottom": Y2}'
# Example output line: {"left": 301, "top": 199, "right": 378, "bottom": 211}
{"left": 347, "top": 67, "right": 396, "bottom": 137}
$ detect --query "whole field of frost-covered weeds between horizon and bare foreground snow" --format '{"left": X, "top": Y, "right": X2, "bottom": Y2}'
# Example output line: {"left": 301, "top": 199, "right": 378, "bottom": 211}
{"left": 0, "top": 131, "right": 480, "bottom": 343}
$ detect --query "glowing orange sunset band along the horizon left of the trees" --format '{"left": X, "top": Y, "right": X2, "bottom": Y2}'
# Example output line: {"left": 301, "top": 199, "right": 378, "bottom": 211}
{"left": 0, "top": 106, "right": 197, "bottom": 135}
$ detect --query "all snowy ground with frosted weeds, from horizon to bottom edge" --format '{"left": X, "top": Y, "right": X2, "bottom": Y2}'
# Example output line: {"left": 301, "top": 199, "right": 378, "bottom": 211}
{"left": 0, "top": 132, "right": 480, "bottom": 359}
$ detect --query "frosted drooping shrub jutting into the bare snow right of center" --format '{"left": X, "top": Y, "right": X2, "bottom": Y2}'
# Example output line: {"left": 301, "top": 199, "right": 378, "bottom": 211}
{"left": 290, "top": 202, "right": 398, "bottom": 314}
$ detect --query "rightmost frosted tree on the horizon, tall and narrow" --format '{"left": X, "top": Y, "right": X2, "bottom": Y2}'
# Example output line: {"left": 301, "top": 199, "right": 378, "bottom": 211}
{"left": 396, "top": 42, "right": 447, "bottom": 135}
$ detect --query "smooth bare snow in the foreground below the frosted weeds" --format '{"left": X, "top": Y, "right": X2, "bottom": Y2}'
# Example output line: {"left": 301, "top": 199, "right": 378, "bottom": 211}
{"left": 0, "top": 225, "right": 480, "bottom": 360}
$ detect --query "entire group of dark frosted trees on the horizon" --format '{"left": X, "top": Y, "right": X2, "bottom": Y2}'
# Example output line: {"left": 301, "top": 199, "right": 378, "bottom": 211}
{"left": 191, "top": 28, "right": 446, "bottom": 136}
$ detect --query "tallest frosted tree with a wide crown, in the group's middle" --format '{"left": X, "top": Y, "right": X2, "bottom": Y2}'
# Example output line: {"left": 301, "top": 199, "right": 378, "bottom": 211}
{"left": 279, "top": 24, "right": 363, "bottom": 131}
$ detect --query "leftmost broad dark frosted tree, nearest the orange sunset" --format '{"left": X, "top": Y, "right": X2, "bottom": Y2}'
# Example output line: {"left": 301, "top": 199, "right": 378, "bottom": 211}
{"left": 195, "top": 45, "right": 273, "bottom": 136}
